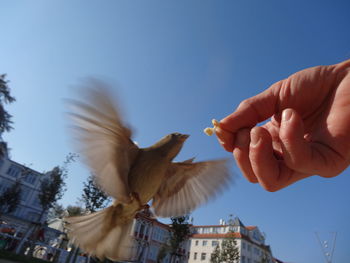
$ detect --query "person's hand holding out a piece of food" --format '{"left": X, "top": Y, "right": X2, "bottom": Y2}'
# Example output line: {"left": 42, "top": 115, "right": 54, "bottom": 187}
{"left": 216, "top": 60, "right": 350, "bottom": 192}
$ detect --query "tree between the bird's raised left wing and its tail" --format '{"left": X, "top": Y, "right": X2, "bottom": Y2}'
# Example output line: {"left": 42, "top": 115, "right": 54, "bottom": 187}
{"left": 81, "top": 175, "right": 111, "bottom": 212}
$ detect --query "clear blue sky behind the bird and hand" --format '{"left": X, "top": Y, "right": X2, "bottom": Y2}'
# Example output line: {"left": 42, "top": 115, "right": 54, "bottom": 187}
{"left": 0, "top": 0, "right": 350, "bottom": 263}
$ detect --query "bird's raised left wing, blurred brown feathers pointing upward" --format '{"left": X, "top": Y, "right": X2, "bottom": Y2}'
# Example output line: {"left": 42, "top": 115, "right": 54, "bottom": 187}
{"left": 68, "top": 80, "right": 139, "bottom": 202}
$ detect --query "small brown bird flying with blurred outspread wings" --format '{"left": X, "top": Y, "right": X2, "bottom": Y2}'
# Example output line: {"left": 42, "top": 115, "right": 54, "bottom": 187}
{"left": 65, "top": 80, "right": 232, "bottom": 260}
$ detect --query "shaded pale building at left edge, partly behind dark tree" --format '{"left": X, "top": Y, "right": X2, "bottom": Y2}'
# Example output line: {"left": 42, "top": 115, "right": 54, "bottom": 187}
{"left": 0, "top": 156, "right": 47, "bottom": 234}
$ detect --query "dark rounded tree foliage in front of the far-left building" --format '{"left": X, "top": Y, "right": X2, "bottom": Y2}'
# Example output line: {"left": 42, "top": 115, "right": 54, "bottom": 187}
{"left": 0, "top": 180, "right": 21, "bottom": 216}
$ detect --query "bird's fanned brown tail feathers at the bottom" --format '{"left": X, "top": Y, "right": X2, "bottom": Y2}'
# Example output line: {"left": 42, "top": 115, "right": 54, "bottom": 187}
{"left": 65, "top": 204, "right": 134, "bottom": 260}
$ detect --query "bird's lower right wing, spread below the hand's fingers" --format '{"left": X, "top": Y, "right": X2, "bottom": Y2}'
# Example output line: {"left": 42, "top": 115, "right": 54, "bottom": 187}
{"left": 152, "top": 160, "right": 232, "bottom": 217}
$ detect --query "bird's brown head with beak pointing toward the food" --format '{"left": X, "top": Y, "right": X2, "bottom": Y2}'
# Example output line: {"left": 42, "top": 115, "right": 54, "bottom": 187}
{"left": 153, "top": 132, "right": 189, "bottom": 160}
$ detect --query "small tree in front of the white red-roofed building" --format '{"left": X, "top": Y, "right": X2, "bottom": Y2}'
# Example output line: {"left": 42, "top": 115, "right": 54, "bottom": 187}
{"left": 210, "top": 232, "right": 239, "bottom": 263}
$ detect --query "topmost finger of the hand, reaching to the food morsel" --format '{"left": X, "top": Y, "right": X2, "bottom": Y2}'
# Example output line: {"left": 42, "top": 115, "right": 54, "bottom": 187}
{"left": 220, "top": 81, "right": 283, "bottom": 133}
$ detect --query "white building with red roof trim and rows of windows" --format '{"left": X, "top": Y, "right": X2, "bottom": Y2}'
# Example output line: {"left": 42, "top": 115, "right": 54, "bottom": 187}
{"left": 188, "top": 217, "right": 274, "bottom": 263}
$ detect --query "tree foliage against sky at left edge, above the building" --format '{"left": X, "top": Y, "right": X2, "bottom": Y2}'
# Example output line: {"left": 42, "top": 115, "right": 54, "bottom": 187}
{"left": 0, "top": 74, "right": 16, "bottom": 134}
